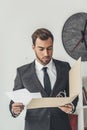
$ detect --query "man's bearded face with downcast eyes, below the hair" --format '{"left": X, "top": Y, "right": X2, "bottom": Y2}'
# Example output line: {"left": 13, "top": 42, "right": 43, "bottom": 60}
{"left": 32, "top": 38, "right": 53, "bottom": 65}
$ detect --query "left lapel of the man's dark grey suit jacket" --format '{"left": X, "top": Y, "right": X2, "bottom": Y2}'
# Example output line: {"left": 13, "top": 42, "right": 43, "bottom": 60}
{"left": 25, "top": 62, "right": 47, "bottom": 97}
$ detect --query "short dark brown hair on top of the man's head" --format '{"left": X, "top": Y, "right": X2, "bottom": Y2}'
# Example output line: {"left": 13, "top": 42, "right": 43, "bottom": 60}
{"left": 32, "top": 28, "right": 54, "bottom": 45}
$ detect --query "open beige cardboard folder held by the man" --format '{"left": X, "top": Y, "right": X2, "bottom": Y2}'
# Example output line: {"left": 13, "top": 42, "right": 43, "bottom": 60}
{"left": 27, "top": 58, "right": 81, "bottom": 109}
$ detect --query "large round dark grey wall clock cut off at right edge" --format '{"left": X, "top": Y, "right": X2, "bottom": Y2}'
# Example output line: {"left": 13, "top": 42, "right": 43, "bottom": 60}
{"left": 62, "top": 12, "right": 87, "bottom": 61}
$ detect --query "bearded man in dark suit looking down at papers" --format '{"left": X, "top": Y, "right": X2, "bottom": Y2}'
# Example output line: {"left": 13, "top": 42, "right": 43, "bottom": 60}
{"left": 10, "top": 28, "right": 78, "bottom": 130}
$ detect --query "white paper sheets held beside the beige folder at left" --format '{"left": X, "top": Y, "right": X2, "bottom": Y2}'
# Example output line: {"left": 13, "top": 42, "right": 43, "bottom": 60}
{"left": 6, "top": 88, "right": 41, "bottom": 106}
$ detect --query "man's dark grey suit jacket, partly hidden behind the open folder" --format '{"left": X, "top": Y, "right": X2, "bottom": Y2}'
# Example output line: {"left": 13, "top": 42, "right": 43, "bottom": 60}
{"left": 10, "top": 59, "right": 78, "bottom": 130}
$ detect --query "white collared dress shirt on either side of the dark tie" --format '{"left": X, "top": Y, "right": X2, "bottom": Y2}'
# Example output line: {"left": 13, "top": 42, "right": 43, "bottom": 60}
{"left": 35, "top": 60, "right": 57, "bottom": 90}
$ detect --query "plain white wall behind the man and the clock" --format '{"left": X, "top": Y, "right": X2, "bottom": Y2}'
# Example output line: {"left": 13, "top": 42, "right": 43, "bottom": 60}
{"left": 0, "top": 0, "right": 87, "bottom": 130}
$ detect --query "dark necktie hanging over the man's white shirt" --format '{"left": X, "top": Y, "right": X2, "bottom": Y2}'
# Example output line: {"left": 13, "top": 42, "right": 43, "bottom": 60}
{"left": 42, "top": 67, "right": 51, "bottom": 96}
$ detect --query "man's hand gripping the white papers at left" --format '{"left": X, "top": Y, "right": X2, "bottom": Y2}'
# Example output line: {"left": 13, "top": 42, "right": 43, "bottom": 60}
{"left": 12, "top": 103, "right": 24, "bottom": 115}
